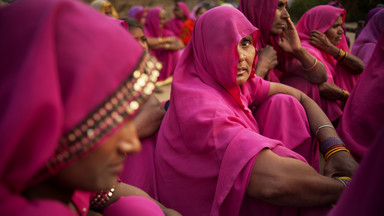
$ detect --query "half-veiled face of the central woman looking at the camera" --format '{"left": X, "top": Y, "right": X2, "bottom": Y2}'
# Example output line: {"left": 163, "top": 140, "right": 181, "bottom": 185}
{"left": 236, "top": 35, "right": 256, "bottom": 86}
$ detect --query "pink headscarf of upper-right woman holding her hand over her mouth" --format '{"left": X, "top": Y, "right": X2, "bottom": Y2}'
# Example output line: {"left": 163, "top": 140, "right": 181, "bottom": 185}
{"left": 296, "top": 5, "right": 358, "bottom": 91}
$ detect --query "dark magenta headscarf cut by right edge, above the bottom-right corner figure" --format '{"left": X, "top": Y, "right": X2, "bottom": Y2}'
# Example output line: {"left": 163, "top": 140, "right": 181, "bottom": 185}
{"left": 337, "top": 32, "right": 384, "bottom": 161}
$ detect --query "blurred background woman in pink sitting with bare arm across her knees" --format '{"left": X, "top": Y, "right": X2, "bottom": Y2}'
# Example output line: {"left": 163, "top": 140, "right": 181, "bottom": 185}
{"left": 144, "top": 7, "right": 184, "bottom": 81}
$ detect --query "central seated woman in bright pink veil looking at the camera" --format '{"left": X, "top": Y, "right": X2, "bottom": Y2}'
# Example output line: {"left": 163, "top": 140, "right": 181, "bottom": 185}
{"left": 155, "top": 7, "right": 357, "bottom": 215}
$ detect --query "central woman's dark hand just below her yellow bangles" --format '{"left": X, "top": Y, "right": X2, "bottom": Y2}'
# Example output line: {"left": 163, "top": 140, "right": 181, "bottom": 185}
{"left": 324, "top": 151, "right": 359, "bottom": 177}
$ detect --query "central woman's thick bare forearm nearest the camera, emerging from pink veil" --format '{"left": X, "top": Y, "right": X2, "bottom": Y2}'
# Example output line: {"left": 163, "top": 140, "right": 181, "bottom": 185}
{"left": 247, "top": 150, "right": 344, "bottom": 207}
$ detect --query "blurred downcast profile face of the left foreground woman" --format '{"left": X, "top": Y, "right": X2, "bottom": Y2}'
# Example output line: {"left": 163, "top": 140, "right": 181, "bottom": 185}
{"left": 54, "top": 120, "right": 141, "bottom": 191}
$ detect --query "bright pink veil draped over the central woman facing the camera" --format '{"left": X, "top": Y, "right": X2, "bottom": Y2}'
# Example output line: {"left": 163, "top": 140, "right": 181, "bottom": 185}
{"left": 155, "top": 6, "right": 305, "bottom": 216}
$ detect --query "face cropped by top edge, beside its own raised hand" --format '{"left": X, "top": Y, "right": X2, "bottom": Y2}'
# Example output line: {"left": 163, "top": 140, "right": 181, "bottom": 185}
{"left": 271, "top": 0, "right": 289, "bottom": 35}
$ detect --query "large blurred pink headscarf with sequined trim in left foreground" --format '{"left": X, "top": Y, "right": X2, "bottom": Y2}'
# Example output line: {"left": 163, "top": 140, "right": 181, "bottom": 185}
{"left": 0, "top": 0, "right": 156, "bottom": 215}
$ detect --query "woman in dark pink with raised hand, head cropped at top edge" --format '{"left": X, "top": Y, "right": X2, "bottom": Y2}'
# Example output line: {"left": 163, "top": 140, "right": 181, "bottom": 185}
{"left": 239, "top": 0, "right": 342, "bottom": 122}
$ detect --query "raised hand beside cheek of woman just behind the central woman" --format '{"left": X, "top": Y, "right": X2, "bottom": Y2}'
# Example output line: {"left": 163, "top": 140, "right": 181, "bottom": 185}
{"left": 279, "top": 18, "right": 301, "bottom": 54}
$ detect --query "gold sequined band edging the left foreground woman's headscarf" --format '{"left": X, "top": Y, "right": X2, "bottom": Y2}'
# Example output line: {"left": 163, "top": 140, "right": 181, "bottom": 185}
{"left": 36, "top": 52, "right": 162, "bottom": 181}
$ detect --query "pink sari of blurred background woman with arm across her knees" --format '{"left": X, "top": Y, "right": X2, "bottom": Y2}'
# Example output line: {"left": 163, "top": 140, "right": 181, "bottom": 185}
{"left": 144, "top": 7, "right": 179, "bottom": 81}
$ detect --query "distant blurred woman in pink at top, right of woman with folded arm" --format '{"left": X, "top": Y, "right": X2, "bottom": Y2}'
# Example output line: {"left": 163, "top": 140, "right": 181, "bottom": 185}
{"left": 166, "top": 1, "right": 190, "bottom": 35}
